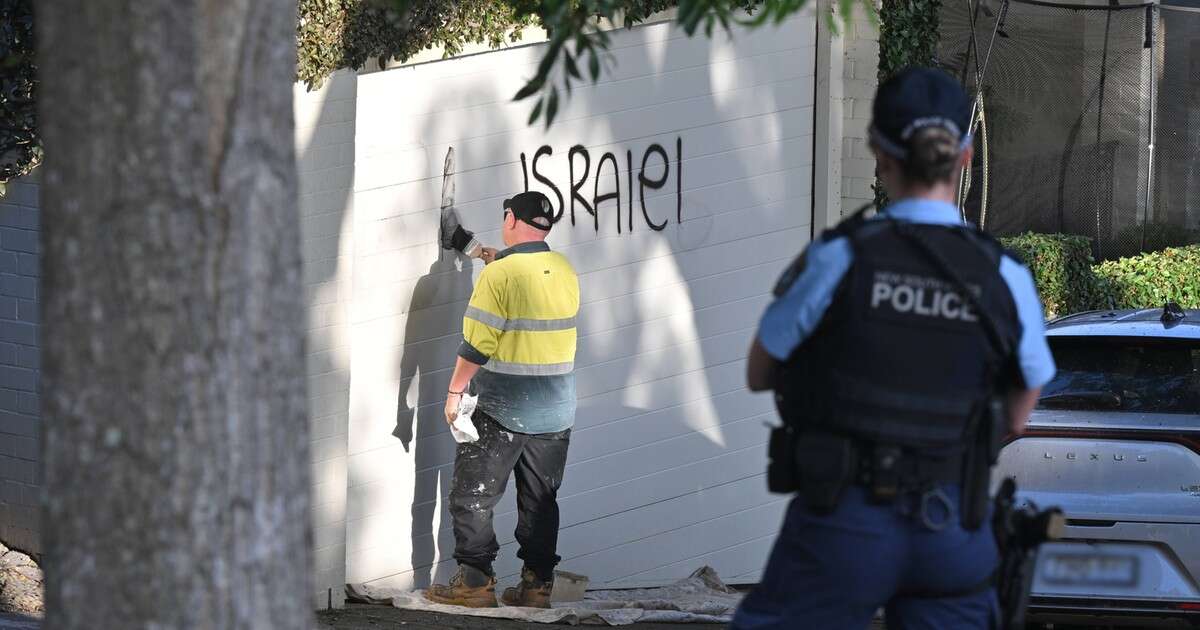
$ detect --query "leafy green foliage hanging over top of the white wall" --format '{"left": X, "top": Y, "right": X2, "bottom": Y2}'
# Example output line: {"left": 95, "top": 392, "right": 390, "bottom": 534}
{"left": 299, "top": 0, "right": 874, "bottom": 125}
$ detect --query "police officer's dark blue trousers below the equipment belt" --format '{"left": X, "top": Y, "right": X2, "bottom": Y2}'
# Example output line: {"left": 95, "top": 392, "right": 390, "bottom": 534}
{"left": 731, "top": 486, "right": 998, "bottom": 630}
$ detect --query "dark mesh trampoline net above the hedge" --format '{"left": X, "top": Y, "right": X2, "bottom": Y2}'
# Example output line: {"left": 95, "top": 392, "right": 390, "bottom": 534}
{"left": 938, "top": 0, "right": 1200, "bottom": 258}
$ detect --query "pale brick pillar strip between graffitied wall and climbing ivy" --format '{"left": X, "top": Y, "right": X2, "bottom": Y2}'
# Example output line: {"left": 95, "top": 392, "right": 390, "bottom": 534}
{"left": 841, "top": 4, "right": 880, "bottom": 215}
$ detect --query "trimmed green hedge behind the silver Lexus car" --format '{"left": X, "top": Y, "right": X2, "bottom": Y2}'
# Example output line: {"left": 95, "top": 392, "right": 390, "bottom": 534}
{"left": 1001, "top": 233, "right": 1200, "bottom": 318}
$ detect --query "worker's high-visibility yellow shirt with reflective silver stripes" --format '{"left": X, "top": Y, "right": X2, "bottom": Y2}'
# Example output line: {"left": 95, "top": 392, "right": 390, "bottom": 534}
{"left": 458, "top": 241, "right": 580, "bottom": 433}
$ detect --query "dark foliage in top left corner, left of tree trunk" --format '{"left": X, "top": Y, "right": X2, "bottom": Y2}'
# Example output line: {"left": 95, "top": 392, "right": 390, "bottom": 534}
{"left": 0, "top": 0, "right": 42, "bottom": 197}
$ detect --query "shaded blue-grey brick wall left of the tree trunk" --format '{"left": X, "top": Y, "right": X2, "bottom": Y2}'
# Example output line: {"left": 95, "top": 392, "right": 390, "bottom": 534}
{"left": 0, "top": 171, "right": 42, "bottom": 554}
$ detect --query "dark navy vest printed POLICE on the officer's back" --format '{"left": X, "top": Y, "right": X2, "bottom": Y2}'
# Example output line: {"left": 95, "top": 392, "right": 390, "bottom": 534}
{"left": 775, "top": 216, "right": 1020, "bottom": 454}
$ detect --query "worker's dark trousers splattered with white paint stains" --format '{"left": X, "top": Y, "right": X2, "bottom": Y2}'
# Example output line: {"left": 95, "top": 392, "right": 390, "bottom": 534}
{"left": 450, "top": 410, "right": 571, "bottom": 580}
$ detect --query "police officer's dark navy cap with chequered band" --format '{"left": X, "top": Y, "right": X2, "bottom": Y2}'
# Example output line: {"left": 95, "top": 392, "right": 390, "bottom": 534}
{"left": 870, "top": 67, "right": 971, "bottom": 160}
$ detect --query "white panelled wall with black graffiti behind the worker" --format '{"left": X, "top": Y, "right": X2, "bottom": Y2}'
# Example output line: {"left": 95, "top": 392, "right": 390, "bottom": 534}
{"left": 346, "top": 16, "right": 820, "bottom": 588}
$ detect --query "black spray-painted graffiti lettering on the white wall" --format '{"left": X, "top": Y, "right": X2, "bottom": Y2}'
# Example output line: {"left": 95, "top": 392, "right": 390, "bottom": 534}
{"left": 521, "top": 137, "right": 683, "bottom": 234}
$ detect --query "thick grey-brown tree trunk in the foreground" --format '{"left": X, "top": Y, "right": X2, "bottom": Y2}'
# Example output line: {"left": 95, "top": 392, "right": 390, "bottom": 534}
{"left": 36, "top": 0, "right": 312, "bottom": 630}
